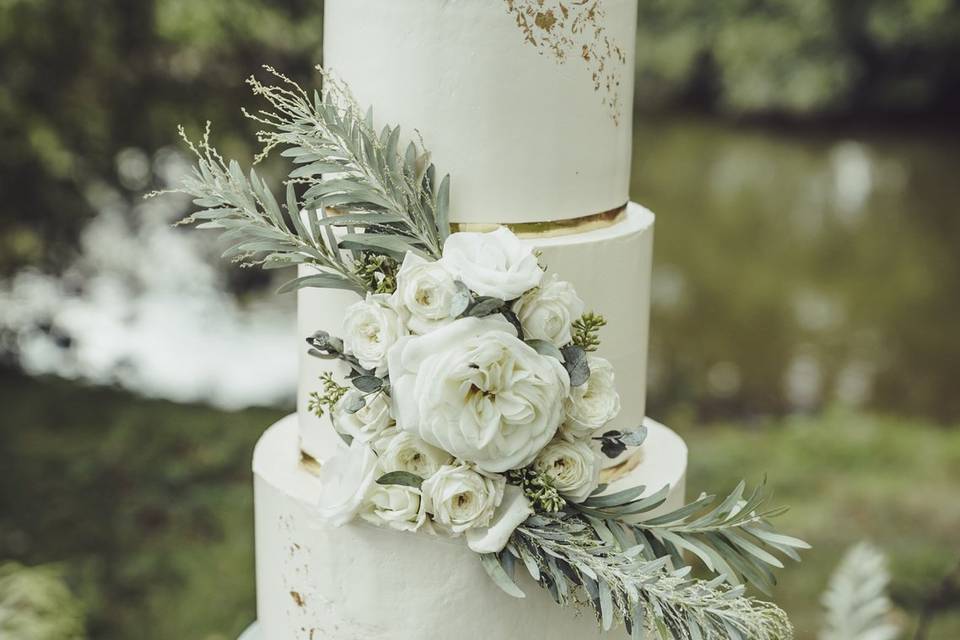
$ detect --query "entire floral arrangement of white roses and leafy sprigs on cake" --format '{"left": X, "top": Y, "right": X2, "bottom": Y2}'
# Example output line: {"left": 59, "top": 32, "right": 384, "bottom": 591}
{"left": 159, "top": 67, "right": 807, "bottom": 640}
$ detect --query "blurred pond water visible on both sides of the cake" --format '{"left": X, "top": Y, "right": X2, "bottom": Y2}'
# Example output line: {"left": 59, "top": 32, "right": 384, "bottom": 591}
{"left": 0, "top": 117, "right": 960, "bottom": 421}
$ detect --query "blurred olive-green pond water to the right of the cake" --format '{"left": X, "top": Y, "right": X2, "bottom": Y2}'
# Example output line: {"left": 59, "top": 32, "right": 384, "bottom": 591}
{"left": 632, "top": 117, "right": 960, "bottom": 421}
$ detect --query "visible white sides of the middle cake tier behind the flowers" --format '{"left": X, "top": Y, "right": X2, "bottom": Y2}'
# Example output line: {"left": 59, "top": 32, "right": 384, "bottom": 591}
{"left": 297, "top": 203, "right": 654, "bottom": 460}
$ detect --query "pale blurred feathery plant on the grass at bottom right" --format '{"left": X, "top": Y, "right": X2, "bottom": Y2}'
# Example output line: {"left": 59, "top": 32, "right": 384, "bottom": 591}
{"left": 820, "top": 543, "right": 900, "bottom": 640}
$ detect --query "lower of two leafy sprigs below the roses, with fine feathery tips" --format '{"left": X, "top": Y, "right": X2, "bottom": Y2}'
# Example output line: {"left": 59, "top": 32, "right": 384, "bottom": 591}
{"left": 483, "top": 514, "right": 792, "bottom": 640}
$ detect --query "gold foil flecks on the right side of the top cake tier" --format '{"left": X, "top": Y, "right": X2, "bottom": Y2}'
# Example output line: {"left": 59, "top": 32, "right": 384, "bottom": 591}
{"left": 504, "top": 0, "right": 627, "bottom": 125}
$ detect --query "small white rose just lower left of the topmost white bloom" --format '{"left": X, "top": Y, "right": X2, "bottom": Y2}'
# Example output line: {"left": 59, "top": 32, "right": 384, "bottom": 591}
{"left": 394, "top": 252, "right": 457, "bottom": 333}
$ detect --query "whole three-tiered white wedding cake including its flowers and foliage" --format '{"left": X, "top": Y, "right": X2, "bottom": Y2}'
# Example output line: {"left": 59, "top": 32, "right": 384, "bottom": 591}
{"left": 169, "top": 0, "right": 805, "bottom": 640}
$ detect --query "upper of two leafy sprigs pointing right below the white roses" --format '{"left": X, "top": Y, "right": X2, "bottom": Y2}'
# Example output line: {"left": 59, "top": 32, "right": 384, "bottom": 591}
{"left": 572, "top": 482, "right": 810, "bottom": 594}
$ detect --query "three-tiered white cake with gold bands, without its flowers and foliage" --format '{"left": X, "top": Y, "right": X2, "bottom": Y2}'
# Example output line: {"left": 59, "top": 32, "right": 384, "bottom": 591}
{"left": 253, "top": 0, "right": 686, "bottom": 640}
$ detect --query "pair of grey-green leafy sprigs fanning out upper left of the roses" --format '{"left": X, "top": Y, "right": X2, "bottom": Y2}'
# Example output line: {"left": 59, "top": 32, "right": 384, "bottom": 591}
{"left": 150, "top": 67, "right": 450, "bottom": 294}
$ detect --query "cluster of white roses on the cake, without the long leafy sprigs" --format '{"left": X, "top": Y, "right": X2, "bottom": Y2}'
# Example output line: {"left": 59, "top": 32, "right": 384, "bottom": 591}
{"left": 319, "top": 227, "right": 620, "bottom": 553}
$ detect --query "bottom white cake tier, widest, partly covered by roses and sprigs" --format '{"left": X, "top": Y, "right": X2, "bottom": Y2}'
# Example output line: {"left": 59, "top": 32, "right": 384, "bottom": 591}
{"left": 253, "top": 415, "right": 687, "bottom": 640}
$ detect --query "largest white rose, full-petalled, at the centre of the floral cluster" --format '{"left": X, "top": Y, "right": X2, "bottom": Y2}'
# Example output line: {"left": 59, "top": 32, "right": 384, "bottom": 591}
{"left": 389, "top": 318, "right": 570, "bottom": 472}
